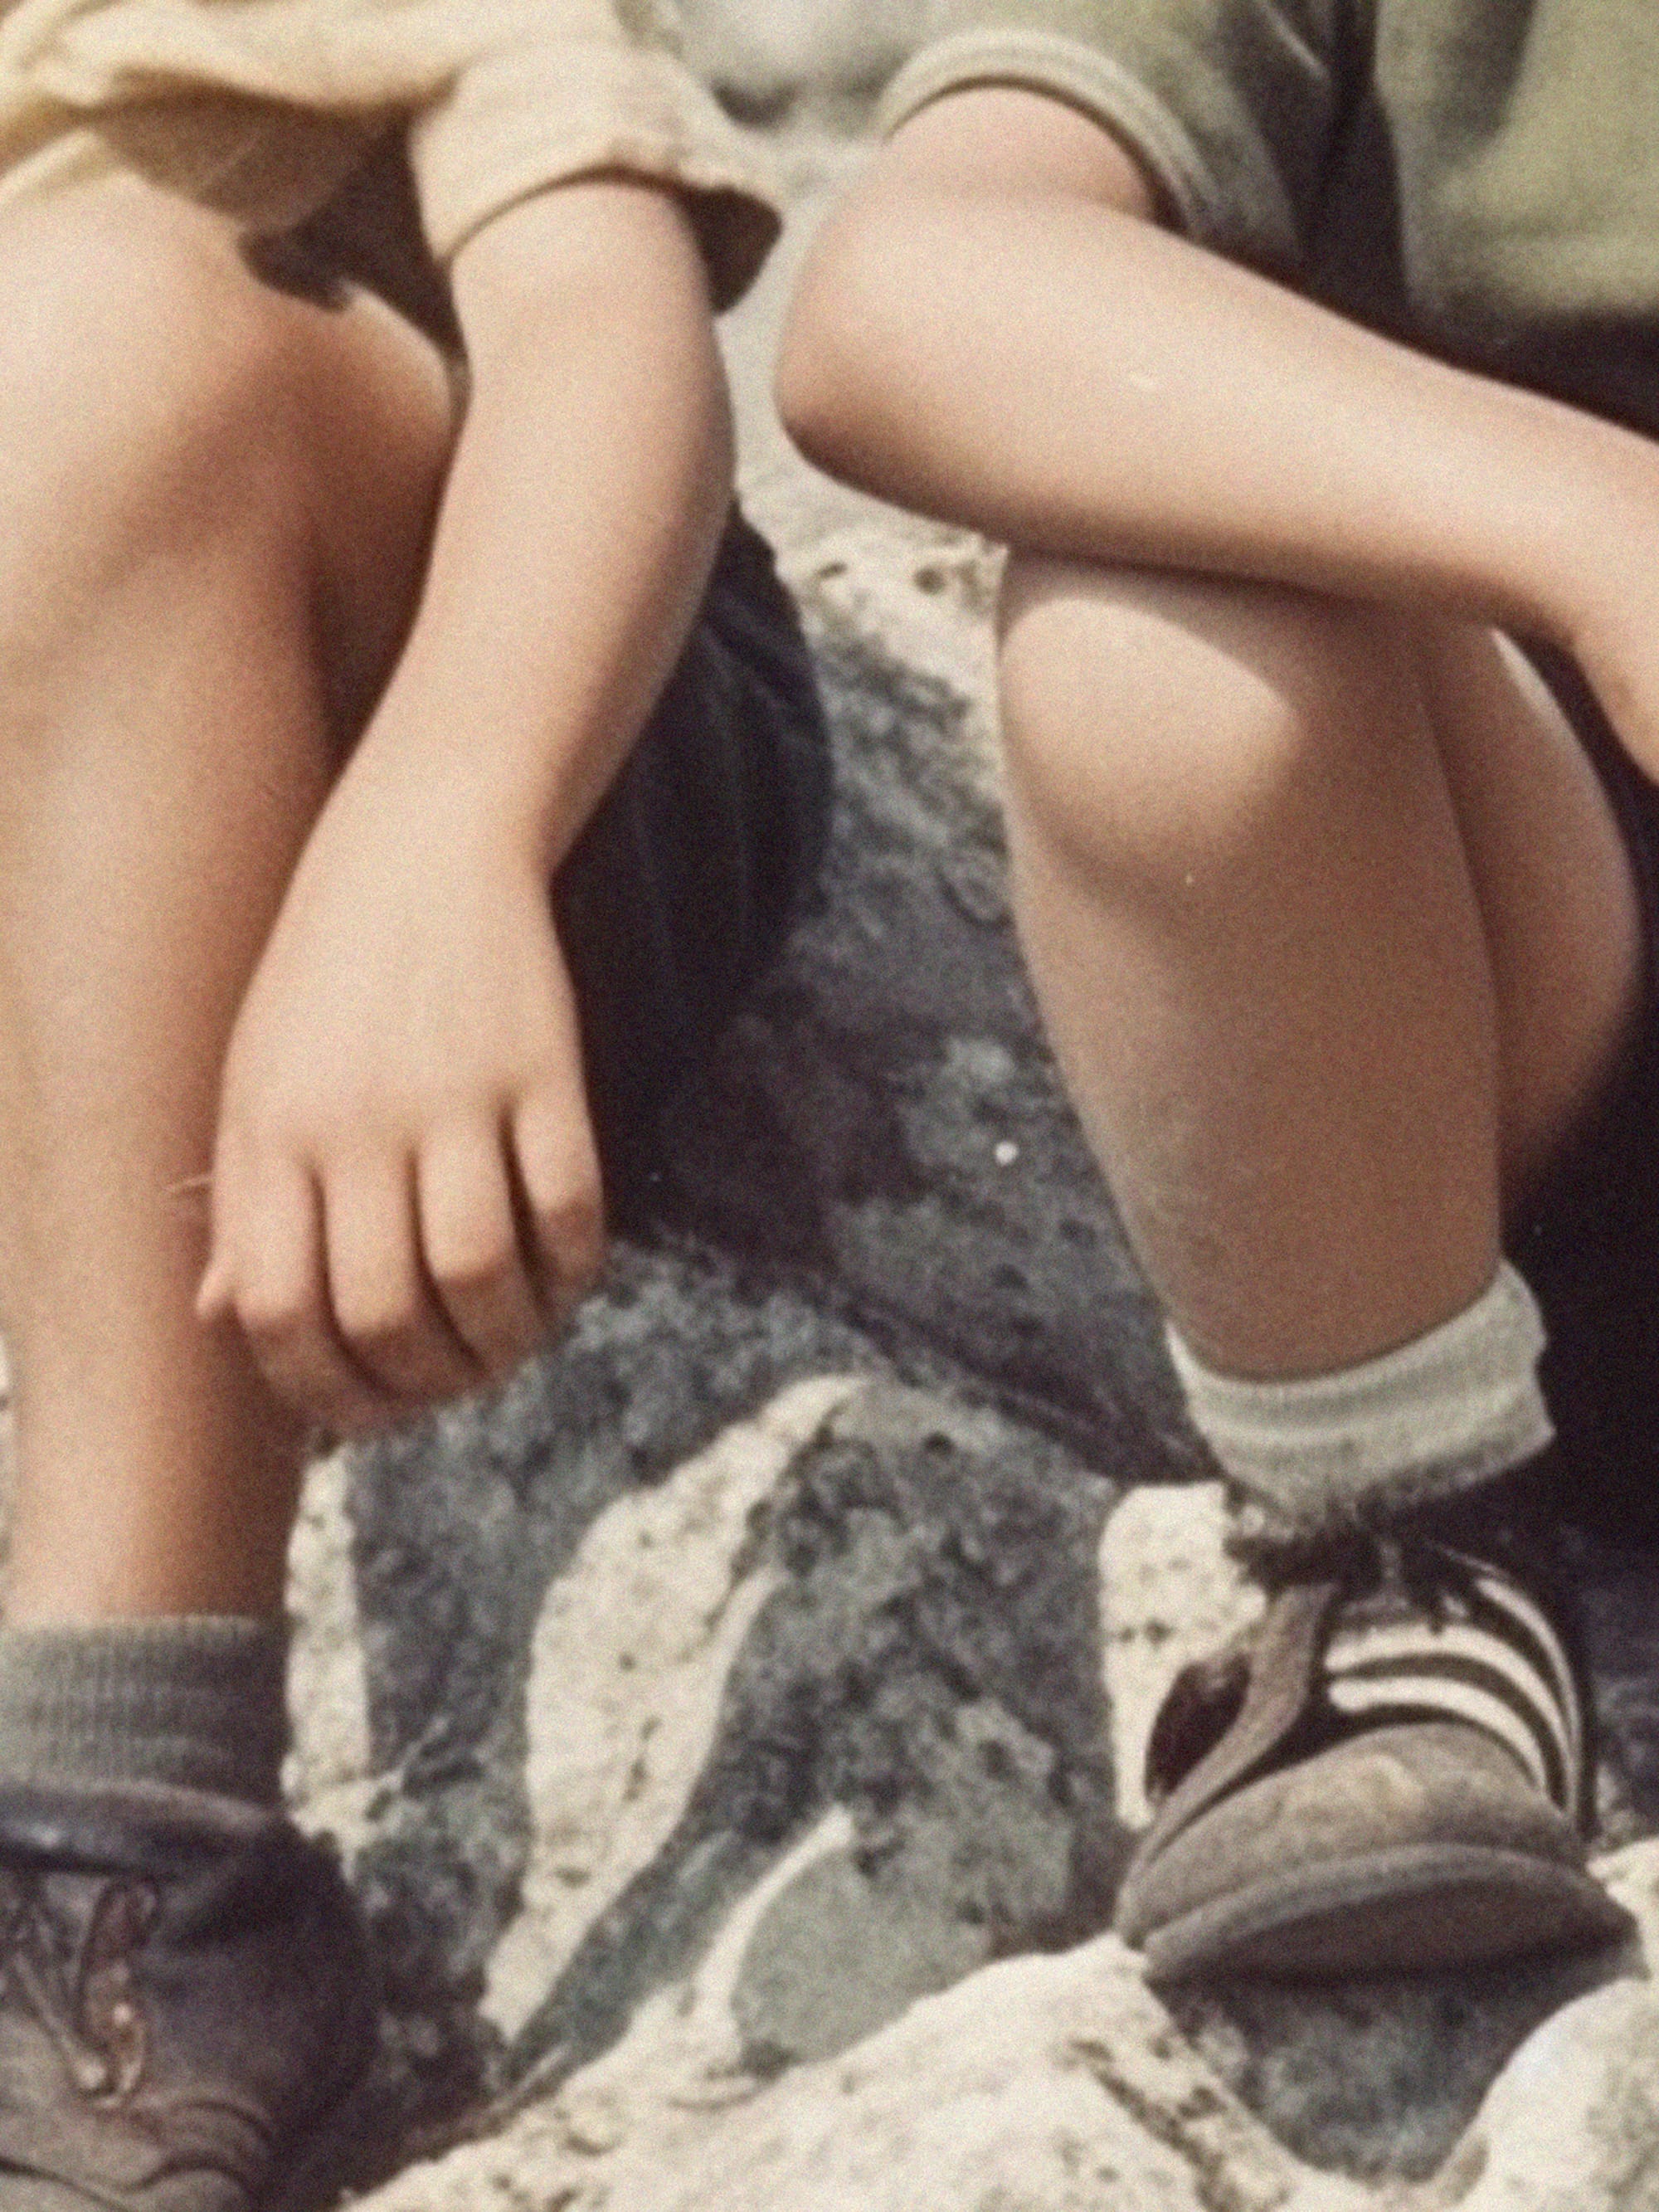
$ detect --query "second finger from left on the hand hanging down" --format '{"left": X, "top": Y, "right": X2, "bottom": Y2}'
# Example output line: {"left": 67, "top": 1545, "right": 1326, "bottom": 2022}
{"left": 323, "top": 1152, "right": 482, "bottom": 1411}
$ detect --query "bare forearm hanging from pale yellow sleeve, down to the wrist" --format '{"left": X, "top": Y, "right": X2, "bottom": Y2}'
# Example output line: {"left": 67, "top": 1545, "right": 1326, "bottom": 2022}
{"left": 352, "top": 182, "right": 732, "bottom": 867}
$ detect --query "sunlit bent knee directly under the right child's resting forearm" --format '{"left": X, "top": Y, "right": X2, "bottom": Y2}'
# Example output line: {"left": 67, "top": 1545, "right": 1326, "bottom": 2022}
{"left": 1000, "top": 555, "right": 1411, "bottom": 883}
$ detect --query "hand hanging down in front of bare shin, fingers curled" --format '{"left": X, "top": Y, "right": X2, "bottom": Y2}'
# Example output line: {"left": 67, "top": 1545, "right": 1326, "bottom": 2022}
{"left": 197, "top": 757, "right": 604, "bottom": 1435}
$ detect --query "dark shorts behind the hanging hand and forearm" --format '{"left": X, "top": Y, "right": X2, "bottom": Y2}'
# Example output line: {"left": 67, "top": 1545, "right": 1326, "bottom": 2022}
{"left": 553, "top": 515, "right": 830, "bottom": 1230}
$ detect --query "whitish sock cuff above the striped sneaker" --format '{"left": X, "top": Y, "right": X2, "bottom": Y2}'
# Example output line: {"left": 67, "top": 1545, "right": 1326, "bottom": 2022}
{"left": 1165, "top": 1261, "right": 1555, "bottom": 1535}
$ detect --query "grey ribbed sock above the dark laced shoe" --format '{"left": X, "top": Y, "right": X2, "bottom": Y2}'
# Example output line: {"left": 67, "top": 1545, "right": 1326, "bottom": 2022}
{"left": 0, "top": 1617, "right": 288, "bottom": 1805}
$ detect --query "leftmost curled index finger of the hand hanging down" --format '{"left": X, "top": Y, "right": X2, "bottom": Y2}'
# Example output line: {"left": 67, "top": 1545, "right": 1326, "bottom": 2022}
{"left": 212, "top": 1159, "right": 398, "bottom": 1435}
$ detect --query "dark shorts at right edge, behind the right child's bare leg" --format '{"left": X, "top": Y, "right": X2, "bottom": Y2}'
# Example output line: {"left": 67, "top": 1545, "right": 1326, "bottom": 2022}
{"left": 1506, "top": 652, "right": 1659, "bottom": 1544}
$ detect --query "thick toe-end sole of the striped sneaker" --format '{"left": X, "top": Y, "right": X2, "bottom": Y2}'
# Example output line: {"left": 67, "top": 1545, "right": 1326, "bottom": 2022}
{"left": 1144, "top": 1844, "right": 1635, "bottom": 1982}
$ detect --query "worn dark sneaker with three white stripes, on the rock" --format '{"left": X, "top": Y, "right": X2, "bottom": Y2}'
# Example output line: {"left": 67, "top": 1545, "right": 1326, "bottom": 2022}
{"left": 1117, "top": 1478, "right": 1630, "bottom": 1982}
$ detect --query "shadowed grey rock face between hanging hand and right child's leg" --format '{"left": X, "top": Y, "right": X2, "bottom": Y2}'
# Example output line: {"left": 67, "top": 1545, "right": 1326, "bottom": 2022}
{"left": 657, "top": 626, "right": 1205, "bottom": 1480}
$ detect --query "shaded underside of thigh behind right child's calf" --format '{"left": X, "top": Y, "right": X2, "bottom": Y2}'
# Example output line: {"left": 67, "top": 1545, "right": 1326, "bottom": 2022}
{"left": 1423, "top": 624, "right": 1646, "bottom": 1215}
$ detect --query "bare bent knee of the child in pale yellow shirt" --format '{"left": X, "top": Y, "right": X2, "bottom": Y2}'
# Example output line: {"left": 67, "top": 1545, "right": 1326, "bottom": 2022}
{"left": 0, "top": 177, "right": 451, "bottom": 716}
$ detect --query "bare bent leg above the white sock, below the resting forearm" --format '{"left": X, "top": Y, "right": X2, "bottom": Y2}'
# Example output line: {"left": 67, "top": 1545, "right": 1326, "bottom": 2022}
{"left": 1002, "top": 559, "right": 1637, "bottom": 1376}
